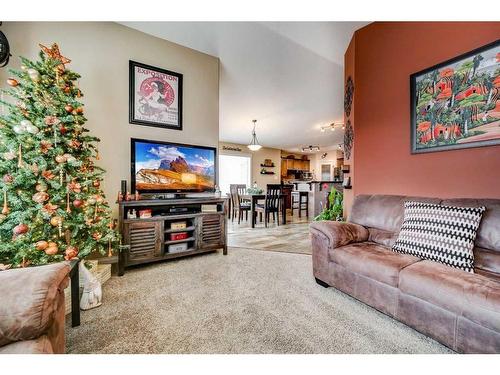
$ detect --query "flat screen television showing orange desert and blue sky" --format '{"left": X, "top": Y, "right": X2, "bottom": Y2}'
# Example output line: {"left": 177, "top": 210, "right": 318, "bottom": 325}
{"left": 131, "top": 138, "right": 216, "bottom": 193}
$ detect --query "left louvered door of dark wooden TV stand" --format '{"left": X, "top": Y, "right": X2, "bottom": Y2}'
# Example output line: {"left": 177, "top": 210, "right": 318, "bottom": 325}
{"left": 125, "top": 221, "right": 163, "bottom": 264}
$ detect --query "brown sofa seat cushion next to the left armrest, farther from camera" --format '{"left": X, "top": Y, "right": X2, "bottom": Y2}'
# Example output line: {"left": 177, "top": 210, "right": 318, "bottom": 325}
{"left": 329, "top": 242, "right": 420, "bottom": 287}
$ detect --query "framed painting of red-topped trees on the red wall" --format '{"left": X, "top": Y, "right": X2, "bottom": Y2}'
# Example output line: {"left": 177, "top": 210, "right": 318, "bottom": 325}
{"left": 410, "top": 40, "right": 500, "bottom": 153}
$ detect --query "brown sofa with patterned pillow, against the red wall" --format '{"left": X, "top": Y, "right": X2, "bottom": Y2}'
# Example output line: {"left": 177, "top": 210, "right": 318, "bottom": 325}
{"left": 310, "top": 195, "right": 500, "bottom": 353}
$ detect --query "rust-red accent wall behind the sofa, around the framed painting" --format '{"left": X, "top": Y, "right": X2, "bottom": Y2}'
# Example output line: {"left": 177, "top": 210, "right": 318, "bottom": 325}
{"left": 352, "top": 22, "right": 500, "bottom": 198}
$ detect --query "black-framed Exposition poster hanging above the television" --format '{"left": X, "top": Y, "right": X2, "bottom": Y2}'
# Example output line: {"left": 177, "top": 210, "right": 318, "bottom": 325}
{"left": 129, "top": 61, "right": 182, "bottom": 130}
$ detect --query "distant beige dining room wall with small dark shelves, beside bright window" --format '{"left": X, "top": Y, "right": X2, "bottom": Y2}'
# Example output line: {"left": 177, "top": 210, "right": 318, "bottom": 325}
{"left": 219, "top": 142, "right": 281, "bottom": 189}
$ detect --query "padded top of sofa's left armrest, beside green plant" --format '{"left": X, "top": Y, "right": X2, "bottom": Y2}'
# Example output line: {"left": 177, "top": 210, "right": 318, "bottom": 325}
{"left": 309, "top": 221, "right": 369, "bottom": 249}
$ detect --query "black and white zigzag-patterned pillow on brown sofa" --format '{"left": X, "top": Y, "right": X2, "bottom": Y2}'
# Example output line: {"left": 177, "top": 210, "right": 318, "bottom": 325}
{"left": 392, "top": 202, "right": 485, "bottom": 273}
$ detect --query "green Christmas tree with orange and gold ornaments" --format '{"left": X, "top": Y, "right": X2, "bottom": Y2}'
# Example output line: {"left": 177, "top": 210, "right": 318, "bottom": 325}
{"left": 0, "top": 44, "right": 118, "bottom": 267}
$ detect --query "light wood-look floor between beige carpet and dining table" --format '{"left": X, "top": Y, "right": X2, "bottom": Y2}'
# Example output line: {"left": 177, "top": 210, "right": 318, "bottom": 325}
{"left": 227, "top": 223, "right": 312, "bottom": 254}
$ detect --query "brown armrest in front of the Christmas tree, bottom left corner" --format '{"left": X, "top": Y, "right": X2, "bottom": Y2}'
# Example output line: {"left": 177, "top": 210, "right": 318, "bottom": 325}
{"left": 0, "top": 262, "right": 70, "bottom": 346}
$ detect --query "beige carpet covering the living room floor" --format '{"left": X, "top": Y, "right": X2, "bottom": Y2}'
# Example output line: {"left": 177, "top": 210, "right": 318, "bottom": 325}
{"left": 66, "top": 248, "right": 449, "bottom": 353}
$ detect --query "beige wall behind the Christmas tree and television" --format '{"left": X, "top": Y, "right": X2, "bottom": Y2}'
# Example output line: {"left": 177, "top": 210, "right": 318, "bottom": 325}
{"left": 0, "top": 22, "right": 219, "bottom": 212}
